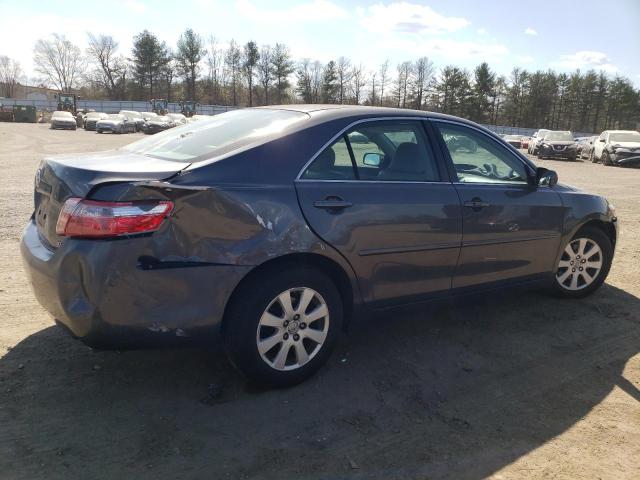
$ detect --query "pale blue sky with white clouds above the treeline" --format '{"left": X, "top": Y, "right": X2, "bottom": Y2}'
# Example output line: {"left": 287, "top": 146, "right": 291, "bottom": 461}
{"left": 0, "top": 0, "right": 640, "bottom": 86}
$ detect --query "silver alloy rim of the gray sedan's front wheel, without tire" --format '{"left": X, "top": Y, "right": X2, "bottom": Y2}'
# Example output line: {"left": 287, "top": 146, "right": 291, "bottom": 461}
{"left": 556, "top": 238, "right": 603, "bottom": 291}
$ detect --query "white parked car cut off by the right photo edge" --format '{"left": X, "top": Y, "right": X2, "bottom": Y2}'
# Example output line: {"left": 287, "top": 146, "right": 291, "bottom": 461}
{"left": 592, "top": 130, "right": 640, "bottom": 167}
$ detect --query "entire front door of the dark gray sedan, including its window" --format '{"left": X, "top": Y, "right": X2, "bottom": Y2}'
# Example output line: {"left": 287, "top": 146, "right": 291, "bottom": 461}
{"left": 433, "top": 121, "right": 564, "bottom": 289}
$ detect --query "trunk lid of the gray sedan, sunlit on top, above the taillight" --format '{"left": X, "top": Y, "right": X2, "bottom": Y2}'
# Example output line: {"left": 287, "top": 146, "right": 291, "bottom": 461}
{"left": 34, "top": 150, "right": 189, "bottom": 249}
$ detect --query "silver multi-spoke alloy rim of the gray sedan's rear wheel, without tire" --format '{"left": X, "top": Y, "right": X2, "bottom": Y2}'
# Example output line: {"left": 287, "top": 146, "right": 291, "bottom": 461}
{"left": 256, "top": 287, "right": 329, "bottom": 371}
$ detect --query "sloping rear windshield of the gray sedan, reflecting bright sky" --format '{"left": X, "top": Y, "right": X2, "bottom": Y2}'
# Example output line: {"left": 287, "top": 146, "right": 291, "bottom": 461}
{"left": 124, "top": 109, "right": 309, "bottom": 162}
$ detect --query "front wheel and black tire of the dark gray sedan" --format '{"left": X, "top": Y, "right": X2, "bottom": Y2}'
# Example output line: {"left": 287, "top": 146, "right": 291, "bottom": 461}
{"left": 553, "top": 227, "right": 613, "bottom": 298}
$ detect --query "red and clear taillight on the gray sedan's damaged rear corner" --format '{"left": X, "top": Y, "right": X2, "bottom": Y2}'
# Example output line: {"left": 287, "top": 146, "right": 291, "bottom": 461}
{"left": 56, "top": 198, "right": 173, "bottom": 238}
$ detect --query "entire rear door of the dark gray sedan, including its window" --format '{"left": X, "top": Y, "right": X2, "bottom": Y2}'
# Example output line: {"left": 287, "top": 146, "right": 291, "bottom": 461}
{"left": 296, "top": 119, "right": 462, "bottom": 306}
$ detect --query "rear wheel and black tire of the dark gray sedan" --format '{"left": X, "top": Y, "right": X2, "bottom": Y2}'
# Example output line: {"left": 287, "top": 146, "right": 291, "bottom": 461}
{"left": 223, "top": 267, "right": 343, "bottom": 387}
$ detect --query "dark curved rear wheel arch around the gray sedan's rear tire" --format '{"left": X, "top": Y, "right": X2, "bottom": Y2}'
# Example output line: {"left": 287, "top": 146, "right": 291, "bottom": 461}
{"left": 221, "top": 252, "right": 360, "bottom": 334}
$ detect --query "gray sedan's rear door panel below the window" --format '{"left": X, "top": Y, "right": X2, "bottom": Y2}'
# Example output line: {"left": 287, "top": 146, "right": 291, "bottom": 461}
{"left": 296, "top": 181, "right": 462, "bottom": 306}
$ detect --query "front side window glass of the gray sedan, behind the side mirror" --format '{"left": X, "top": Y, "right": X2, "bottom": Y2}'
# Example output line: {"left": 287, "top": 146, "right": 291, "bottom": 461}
{"left": 434, "top": 122, "right": 528, "bottom": 184}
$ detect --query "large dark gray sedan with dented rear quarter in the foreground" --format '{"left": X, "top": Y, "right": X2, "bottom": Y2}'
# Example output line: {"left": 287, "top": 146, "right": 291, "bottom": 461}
{"left": 21, "top": 105, "right": 617, "bottom": 386}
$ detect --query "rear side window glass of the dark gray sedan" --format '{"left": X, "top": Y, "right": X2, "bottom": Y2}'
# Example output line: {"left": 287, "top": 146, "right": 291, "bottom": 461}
{"left": 301, "top": 121, "right": 440, "bottom": 182}
